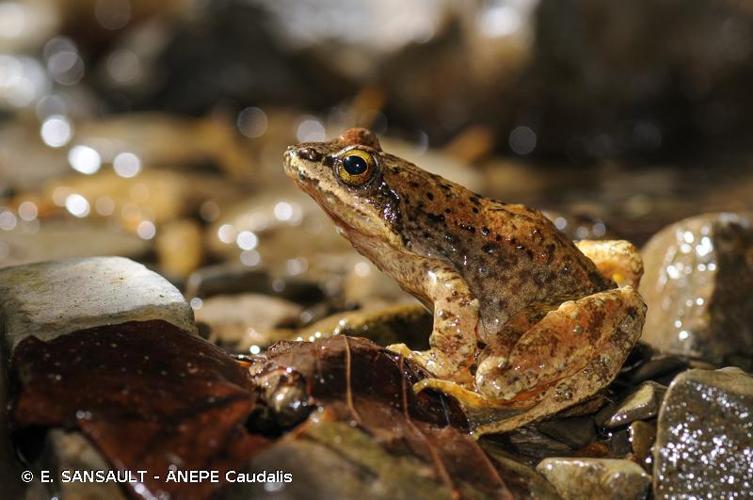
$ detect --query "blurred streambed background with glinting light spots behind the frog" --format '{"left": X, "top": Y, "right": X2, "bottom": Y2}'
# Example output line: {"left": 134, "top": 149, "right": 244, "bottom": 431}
{"left": 0, "top": 0, "right": 753, "bottom": 350}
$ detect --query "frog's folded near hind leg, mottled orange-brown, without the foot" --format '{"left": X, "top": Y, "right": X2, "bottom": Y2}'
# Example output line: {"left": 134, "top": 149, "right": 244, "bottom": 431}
{"left": 476, "top": 286, "right": 646, "bottom": 402}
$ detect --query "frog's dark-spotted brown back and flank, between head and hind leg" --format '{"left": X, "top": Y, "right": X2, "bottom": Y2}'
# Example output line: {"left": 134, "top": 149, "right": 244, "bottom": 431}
{"left": 390, "top": 164, "right": 614, "bottom": 330}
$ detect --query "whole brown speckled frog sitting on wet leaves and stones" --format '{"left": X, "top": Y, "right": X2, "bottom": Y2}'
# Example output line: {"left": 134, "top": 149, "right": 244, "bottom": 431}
{"left": 285, "top": 129, "right": 645, "bottom": 433}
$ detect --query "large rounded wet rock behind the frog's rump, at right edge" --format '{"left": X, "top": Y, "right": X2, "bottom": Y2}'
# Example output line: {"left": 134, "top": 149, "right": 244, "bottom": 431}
{"left": 640, "top": 213, "right": 753, "bottom": 363}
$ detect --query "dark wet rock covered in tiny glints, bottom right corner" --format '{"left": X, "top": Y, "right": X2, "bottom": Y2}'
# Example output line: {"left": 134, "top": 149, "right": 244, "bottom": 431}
{"left": 654, "top": 369, "right": 753, "bottom": 499}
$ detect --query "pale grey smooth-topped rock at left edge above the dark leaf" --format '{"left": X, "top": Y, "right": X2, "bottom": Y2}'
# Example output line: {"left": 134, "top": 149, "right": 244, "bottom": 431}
{"left": 0, "top": 257, "right": 196, "bottom": 346}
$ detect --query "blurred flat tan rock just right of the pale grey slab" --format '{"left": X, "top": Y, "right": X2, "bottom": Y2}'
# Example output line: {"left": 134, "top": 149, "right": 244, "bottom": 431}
{"left": 193, "top": 294, "right": 303, "bottom": 354}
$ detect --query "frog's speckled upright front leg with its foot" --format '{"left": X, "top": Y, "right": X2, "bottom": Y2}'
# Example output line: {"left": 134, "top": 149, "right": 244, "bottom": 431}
{"left": 388, "top": 266, "right": 479, "bottom": 385}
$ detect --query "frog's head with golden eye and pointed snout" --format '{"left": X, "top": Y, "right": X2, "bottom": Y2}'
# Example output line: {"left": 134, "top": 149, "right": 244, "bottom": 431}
{"left": 285, "top": 128, "right": 401, "bottom": 246}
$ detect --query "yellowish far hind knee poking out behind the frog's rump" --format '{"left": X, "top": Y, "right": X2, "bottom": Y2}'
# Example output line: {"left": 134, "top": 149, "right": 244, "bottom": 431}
{"left": 575, "top": 240, "right": 643, "bottom": 288}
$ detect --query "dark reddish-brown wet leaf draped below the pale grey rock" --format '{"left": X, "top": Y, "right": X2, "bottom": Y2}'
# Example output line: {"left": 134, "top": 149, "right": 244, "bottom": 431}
{"left": 12, "top": 321, "right": 269, "bottom": 498}
